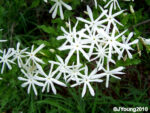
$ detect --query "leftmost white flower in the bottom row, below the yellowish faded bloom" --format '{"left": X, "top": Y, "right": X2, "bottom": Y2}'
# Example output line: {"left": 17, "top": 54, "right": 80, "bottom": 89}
{"left": 18, "top": 69, "right": 44, "bottom": 95}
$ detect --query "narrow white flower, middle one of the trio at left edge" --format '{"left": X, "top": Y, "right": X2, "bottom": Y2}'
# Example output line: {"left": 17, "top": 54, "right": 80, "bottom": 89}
{"left": 14, "top": 42, "right": 28, "bottom": 67}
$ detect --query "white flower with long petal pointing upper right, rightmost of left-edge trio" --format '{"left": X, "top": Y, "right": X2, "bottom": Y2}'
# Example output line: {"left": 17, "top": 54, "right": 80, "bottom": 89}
{"left": 25, "top": 44, "right": 45, "bottom": 64}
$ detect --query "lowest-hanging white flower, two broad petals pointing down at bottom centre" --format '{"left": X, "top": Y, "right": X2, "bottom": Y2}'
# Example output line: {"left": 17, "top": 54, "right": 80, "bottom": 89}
{"left": 71, "top": 66, "right": 103, "bottom": 97}
